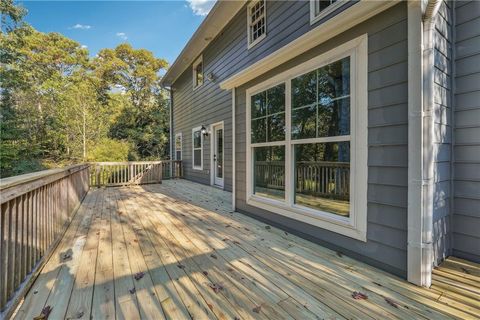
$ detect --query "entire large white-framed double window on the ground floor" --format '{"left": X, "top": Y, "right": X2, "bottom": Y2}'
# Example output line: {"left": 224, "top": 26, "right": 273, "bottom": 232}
{"left": 247, "top": 36, "right": 367, "bottom": 240}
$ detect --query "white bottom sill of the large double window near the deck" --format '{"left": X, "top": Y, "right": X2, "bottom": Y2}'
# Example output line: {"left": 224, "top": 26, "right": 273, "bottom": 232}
{"left": 247, "top": 195, "right": 367, "bottom": 242}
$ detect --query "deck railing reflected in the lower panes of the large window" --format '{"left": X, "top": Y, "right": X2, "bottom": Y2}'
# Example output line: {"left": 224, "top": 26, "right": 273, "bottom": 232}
{"left": 255, "top": 161, "right": 350, "bottom": 200}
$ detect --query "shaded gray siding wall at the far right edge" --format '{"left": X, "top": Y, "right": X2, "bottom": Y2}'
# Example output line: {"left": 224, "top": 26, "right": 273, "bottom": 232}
{"left": 452, "top": 1, "right": 480, "bottom": 262}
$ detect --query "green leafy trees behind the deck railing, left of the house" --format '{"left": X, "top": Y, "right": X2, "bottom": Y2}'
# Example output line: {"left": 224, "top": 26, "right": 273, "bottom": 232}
{"left": 0, "top": 0, "right": 169, "bottom": 177}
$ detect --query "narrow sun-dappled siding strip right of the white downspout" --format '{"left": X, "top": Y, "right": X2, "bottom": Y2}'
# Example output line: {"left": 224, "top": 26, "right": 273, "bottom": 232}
{"left": 431, "top": 1, "right": 453, "bottom": 265}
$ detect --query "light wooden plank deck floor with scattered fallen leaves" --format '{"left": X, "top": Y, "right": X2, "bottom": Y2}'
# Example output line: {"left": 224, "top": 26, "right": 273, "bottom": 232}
{"left": 10, "top": 180, "right": 480, "bottom": 320}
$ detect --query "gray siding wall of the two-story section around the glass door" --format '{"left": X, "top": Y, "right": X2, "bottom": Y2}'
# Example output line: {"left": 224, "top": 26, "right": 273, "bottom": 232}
{"left": 172, "top": 1, "right": 355, "bottom": 191}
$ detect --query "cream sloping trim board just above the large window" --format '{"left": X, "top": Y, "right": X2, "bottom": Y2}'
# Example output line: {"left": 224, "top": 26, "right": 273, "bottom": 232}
{"left": 220, "top": 0, "right": 400, "bottom": 90}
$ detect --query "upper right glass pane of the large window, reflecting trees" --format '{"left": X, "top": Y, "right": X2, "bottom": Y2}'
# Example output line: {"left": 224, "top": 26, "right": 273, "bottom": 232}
{"left": 291, "top": 57, "right": 350, "bottom": 139}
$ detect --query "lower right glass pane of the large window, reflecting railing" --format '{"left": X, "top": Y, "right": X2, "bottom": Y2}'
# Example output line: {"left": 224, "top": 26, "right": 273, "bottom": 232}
{"left": 294, "top": 142, "right": 350, "bottom": 217}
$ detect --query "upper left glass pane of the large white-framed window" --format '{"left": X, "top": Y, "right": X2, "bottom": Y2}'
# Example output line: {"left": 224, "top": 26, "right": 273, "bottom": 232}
{"left": 251, "top": 83, "right": 285, "bottom": 143}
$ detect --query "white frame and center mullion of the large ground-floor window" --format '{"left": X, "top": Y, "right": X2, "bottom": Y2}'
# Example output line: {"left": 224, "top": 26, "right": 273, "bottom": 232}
{"left": 246, "top": 34, "right": 368, "bottom": 241}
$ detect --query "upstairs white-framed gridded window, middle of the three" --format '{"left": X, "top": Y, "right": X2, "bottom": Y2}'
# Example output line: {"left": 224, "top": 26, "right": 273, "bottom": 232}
{"left": 247, "top": 0, "right": 267, "bottom": 49}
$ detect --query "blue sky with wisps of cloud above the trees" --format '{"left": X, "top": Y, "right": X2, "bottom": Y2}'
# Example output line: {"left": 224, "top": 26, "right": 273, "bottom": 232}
{"left": 18, "top": 0, "right": 214, "bottom": 63}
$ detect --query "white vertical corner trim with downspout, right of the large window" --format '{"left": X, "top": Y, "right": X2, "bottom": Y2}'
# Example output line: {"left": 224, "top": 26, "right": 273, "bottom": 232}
{"left": 407, "top": 0, "right": 441, "bottom": 287}
